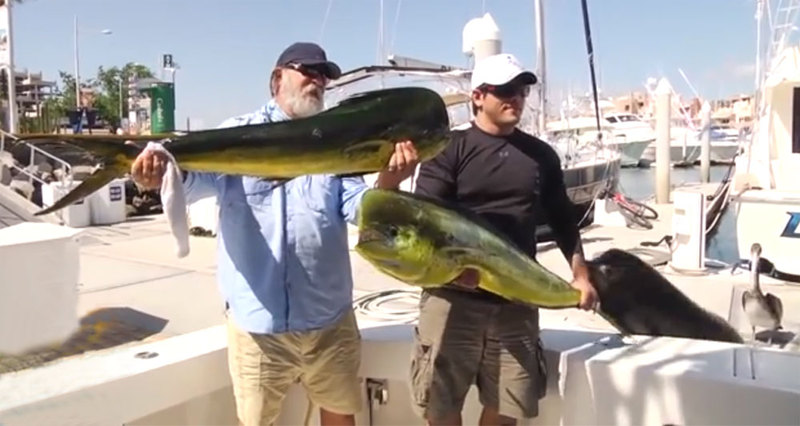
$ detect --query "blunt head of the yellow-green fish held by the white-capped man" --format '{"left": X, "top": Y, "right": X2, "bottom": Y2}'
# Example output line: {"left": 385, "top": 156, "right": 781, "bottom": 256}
{"left": 355, "top": 189, "right": 436, "bottom": 284}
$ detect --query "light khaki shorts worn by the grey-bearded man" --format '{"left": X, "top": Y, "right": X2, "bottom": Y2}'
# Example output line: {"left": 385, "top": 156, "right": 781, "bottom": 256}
{"left": 228, "top": 310, "right": 361, "bottom": 426}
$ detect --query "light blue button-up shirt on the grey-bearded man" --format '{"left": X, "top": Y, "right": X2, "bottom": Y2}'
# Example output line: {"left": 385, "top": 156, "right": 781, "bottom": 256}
{"left": 184, "top": 100, "right": 368, "bottom": 333}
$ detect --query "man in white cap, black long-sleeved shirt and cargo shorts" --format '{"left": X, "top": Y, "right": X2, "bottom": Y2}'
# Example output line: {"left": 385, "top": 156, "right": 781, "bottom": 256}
{"left": 410, "top": 54, "right": 597, "bottom": 425}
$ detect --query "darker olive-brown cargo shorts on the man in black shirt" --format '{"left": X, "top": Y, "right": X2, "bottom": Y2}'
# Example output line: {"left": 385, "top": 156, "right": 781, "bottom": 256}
{"left": 409, "top": 289, "right": 547, "bottom": 420}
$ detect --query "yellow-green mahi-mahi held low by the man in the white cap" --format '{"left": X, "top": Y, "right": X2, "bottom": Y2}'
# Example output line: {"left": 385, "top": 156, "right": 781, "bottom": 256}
{"left": 355, "top": 189, "right": 580, "bottom": 308}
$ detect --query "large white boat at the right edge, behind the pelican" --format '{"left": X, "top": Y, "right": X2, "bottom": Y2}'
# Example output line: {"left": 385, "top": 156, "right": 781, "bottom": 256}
{"left": 732, "top": 38, "right": 800, "bottom": 274}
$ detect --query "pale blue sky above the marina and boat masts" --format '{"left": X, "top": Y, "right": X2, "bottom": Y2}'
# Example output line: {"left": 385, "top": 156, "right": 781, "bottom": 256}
{"left": 7, "top": 0, "right": 768, "bottom": 130}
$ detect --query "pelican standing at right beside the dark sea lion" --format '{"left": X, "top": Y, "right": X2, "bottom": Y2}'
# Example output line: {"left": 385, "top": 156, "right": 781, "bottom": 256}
{"left": 742, "top": 243, "right": 783, "bottom": 344}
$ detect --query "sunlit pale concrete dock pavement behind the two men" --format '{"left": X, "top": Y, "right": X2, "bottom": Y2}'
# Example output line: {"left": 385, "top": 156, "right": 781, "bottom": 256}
{"left": 0, "top": 184, "right": 800, "bottom": 373}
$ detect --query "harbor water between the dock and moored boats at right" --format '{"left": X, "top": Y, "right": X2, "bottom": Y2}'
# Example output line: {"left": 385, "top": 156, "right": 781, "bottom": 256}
{"left": 619, "top": 165, "right": 739, "bottom": 263}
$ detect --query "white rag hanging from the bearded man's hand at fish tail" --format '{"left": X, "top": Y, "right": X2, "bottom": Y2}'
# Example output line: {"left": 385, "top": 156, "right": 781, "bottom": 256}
{"left": 144, "top": 142, "right": 189, "bottom": 257}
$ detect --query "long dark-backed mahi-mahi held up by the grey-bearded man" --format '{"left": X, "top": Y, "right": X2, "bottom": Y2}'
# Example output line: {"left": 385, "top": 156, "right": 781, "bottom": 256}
{"left": 19, "top": 87, "right": 450, "bottom": 215}
